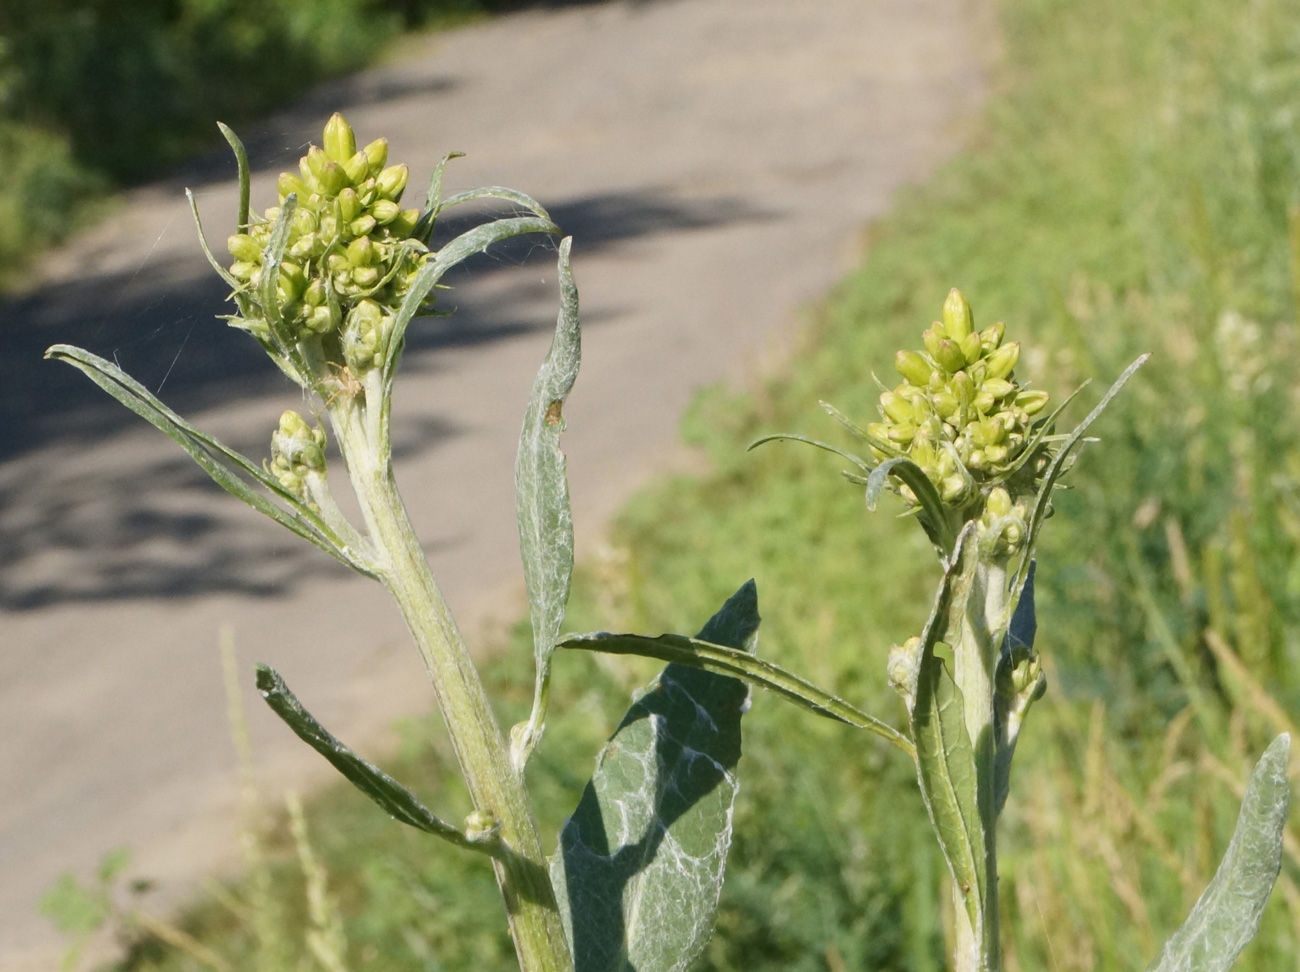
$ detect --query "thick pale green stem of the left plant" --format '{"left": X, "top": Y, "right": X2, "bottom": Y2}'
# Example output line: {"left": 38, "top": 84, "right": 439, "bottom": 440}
{"left": 330, "top": 400, "right": 573, "bottom": 972}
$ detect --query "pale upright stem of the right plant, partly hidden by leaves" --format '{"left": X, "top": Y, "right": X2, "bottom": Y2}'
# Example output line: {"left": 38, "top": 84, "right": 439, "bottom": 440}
{"left": 953, "top": 559, "right": 1009, "bottom": 972}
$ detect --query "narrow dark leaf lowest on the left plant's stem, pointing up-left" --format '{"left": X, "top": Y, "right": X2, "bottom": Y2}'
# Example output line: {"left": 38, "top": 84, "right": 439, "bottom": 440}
{"left": 257, "top": 665, "right": 495, "bottom": 852}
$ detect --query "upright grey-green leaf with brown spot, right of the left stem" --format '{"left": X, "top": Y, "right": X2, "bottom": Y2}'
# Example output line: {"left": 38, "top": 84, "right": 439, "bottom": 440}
{"left": 512, "top": 238, "right": 582, "bottom": 768}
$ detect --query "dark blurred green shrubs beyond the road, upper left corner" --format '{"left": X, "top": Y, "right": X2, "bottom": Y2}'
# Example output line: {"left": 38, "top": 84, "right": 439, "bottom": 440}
{"left": 0, "top": 0, "right": 538, "bottom": 287}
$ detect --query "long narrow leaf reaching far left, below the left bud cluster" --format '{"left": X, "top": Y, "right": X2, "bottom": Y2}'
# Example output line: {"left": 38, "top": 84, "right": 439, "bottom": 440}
{"left": 46, "top": 344, "right": 378, "bottom": 577}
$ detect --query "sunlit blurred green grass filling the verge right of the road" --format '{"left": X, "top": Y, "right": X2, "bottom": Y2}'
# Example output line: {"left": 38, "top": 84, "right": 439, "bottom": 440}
{"left": 40, "top": 0, "right": 1300, "bottom": 972}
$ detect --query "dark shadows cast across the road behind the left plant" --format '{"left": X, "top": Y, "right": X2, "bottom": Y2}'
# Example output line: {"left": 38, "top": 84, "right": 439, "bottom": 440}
{"left": 0, "top": 191, "right": 771, "bottom": 609}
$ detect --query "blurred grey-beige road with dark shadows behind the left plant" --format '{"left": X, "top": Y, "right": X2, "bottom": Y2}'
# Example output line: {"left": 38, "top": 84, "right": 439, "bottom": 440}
{"left": 0, "top": 0, "right": 982, "bottom": 969}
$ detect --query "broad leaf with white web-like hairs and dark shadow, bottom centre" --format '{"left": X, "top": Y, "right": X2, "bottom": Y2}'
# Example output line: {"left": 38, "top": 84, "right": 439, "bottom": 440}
{"left": 551, "top": 581, "right": 758, "bottom": 972}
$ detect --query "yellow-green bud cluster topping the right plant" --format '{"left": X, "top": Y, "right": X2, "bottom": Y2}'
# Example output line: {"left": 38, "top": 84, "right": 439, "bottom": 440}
{"left": 867, "top": 290, "right": 1048, "bottom": 517}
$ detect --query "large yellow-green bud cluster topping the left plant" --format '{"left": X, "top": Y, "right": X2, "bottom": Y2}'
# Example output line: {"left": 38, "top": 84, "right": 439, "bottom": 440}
{"left": 228, "top": 113, "right": 428, "bottom": 370}
